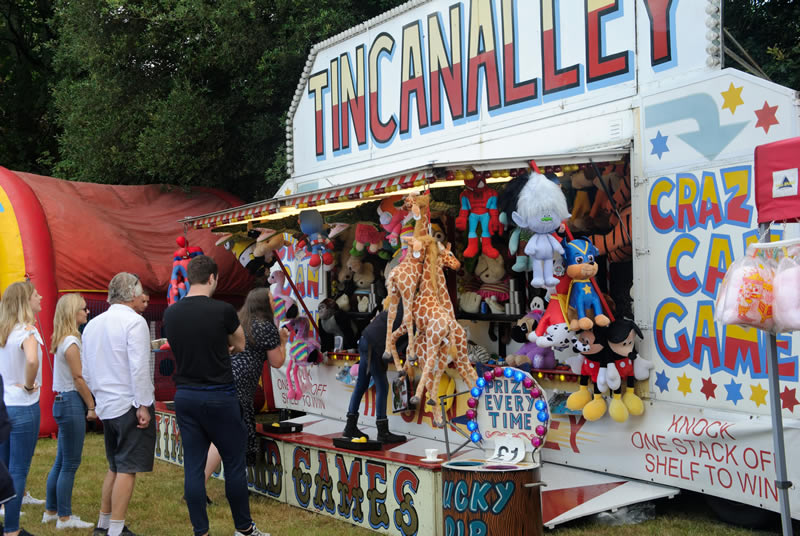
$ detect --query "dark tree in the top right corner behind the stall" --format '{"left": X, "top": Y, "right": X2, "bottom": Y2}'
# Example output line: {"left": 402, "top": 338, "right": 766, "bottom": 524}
{"left": 722, "top": 0, "right": 800, "bottom": 89}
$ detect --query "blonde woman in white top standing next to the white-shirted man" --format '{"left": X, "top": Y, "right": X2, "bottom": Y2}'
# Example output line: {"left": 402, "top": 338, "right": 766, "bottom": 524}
{"left": 42, "top": 294, "right": 97, "bottom": 529}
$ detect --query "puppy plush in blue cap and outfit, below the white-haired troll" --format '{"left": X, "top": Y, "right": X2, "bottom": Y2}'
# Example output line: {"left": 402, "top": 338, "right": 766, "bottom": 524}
{"left": 564, "top": 238, "right": 611, "bottom": 331}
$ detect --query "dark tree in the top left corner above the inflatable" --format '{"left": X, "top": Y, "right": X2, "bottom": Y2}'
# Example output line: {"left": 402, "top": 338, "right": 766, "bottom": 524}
{"left": 0, "top": 0, "right": 57, "bottom": 174}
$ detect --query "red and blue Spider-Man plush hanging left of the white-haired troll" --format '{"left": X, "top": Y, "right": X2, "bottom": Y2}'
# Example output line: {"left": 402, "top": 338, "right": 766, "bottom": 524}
{"left": 456, "top": 171, "right": 503, "bottom": 255}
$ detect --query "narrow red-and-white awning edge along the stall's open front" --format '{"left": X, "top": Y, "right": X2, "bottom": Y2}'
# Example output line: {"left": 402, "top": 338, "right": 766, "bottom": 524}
{"left": 180, "top": 171, "right": 436, "bottom": 229}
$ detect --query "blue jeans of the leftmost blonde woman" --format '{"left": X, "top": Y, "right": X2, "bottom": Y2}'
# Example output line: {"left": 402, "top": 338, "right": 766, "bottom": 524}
{"left": 0, "top": 402, "right": 40, "bottom": 532}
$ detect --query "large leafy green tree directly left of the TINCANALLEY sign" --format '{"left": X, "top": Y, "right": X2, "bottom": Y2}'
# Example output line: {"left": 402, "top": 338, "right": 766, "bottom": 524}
{"left": 54, "top": 0, "right": 402, "bottom": 200}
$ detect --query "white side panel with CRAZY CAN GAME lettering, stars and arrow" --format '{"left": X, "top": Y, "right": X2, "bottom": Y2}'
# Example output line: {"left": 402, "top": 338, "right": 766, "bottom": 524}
{"left": 634, "top": 71, "right": 800, "bottom": 420}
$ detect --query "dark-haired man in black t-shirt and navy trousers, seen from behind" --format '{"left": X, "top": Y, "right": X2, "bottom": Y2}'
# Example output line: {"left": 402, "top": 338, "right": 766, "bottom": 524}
{"left": 164, "top": 255, "right": 264, "bottom": 536}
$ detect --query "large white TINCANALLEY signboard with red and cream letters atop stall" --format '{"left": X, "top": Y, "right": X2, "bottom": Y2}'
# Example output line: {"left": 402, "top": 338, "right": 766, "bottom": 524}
{"left": 286, "top": 0, "right": 719, "bottom": 195}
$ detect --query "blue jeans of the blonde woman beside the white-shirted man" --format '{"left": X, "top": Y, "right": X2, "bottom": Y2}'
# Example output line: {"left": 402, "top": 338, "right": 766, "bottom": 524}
{"left": 45, "top": 391, "right": 86, "bottom": 517}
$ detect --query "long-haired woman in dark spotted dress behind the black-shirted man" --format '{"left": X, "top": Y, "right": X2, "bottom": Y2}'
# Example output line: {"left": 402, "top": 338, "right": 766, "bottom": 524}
{"left": 205, "top": 287, "right": 289, "bottom": 480}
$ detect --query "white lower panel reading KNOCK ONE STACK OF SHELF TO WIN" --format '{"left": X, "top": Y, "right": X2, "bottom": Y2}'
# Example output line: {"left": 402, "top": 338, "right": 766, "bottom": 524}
{"left": 542, "top": 402, "right": 800, "bottom": 517}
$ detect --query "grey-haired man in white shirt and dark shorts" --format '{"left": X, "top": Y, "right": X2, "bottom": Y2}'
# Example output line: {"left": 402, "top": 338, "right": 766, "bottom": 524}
{"left": 83, "top": 272, "right": 156, "bottom": 536}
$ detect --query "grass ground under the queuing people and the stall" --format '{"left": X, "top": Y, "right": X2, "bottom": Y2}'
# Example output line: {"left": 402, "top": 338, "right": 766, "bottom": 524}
{"left": 12, "top": 434, "right": 780, "bottom": 536}
